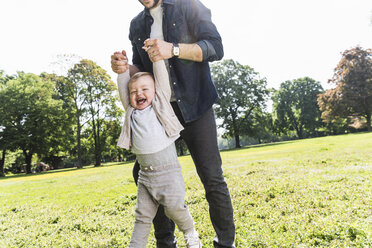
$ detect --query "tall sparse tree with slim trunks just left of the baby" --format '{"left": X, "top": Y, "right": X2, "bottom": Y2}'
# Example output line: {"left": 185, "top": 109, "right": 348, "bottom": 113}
{"left": 68, "top": 59, "right": 117, "bottom": 166}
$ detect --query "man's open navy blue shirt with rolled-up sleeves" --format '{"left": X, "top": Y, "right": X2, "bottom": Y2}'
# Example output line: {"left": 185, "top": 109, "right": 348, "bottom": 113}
{"left": 129, "top": 0, "right": 223, "bottom": 122}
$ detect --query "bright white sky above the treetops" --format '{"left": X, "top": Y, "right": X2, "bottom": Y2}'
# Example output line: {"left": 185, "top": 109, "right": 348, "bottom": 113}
{"left": 0, "top": 0, "right": 372, "bottom": 88}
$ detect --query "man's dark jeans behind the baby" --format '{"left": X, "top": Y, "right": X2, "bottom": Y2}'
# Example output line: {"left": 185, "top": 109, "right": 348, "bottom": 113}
{"left": 133, "top": 103, "right": 235, "bottom": 248}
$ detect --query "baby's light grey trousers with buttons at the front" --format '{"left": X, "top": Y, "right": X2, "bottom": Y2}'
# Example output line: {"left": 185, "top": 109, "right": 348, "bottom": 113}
{"left": 129, "top": 143, "right": 194, "bottom": 248}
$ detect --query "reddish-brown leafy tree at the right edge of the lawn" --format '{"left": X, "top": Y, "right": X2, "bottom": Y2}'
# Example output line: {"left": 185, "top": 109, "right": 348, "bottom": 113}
{"left": 318, "top": 46, "right": 372, "bottom": 131}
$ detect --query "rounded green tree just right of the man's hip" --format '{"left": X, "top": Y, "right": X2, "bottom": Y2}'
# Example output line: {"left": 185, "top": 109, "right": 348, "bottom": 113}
{"left": 211, "top": 59, "right": 268, "bottom": 148}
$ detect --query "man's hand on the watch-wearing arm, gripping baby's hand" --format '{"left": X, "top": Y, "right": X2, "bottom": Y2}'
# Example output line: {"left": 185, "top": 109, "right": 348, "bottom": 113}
{"left": 142, "top": 39, "right": 173, "bottom": 62}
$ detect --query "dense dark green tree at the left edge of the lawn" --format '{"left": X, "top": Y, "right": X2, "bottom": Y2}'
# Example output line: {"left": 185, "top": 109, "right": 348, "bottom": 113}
{"left": 0, "top": 72, "right": 63, "bottom": 173}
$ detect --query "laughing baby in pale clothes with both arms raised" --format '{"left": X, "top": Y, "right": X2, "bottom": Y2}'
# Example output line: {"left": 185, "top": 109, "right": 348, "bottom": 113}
{"left": 118, "top": 56, "right": 202, "bottom": 248}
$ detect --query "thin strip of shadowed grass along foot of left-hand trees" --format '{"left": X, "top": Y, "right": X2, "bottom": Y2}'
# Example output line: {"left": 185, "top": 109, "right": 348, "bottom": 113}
{"left": 0, "top": 161, "right": 134, "bottom": 181}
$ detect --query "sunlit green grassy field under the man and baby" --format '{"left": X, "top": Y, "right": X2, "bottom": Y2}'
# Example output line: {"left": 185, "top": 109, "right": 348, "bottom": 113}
{"left": 0, "top": 133, "right": 372, "bottom": 248}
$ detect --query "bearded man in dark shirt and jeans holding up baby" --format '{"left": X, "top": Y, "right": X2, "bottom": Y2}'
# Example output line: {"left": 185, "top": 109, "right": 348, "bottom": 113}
{"left": 111, "top": 0, "right": 235, "bottom": 248}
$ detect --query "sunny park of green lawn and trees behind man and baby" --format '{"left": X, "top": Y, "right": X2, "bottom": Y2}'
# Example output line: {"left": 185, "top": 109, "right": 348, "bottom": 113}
{"left": 0, "top": 44, "right": 372, "bottom": 248}
